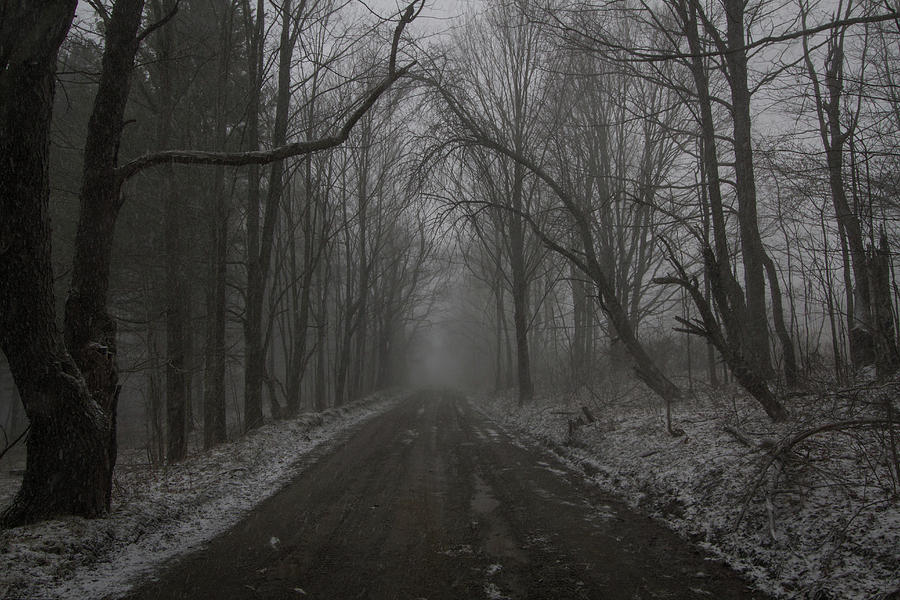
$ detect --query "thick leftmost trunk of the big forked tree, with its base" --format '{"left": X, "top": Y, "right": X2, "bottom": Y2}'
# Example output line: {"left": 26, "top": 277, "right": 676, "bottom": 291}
{"left": 0, "top": 1, "right": 116, "bottom": 525}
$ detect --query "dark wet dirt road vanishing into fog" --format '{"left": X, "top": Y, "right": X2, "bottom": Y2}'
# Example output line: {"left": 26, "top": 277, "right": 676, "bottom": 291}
{"left": 129, "top": 392, "right": 765, "bottom": 600}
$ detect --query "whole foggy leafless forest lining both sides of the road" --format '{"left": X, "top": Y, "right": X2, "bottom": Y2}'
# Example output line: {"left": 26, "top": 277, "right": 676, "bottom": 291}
{"left": 0, "top": 0, "right": 900, "bottom": 598}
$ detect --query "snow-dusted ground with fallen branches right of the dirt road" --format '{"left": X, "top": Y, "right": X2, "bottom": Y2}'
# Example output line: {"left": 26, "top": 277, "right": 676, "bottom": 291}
{"left": 474, "top": 384, "right": 900, "bottom": 600}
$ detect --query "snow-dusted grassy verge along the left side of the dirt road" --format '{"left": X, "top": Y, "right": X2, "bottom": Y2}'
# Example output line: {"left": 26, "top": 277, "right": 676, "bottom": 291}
{"left": 0, "top": 394, "right": 400, "bottom": 600}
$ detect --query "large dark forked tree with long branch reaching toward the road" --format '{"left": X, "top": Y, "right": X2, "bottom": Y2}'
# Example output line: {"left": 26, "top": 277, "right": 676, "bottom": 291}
{"left": 0, "top": 0, "right": 421, "bottom": 524}
